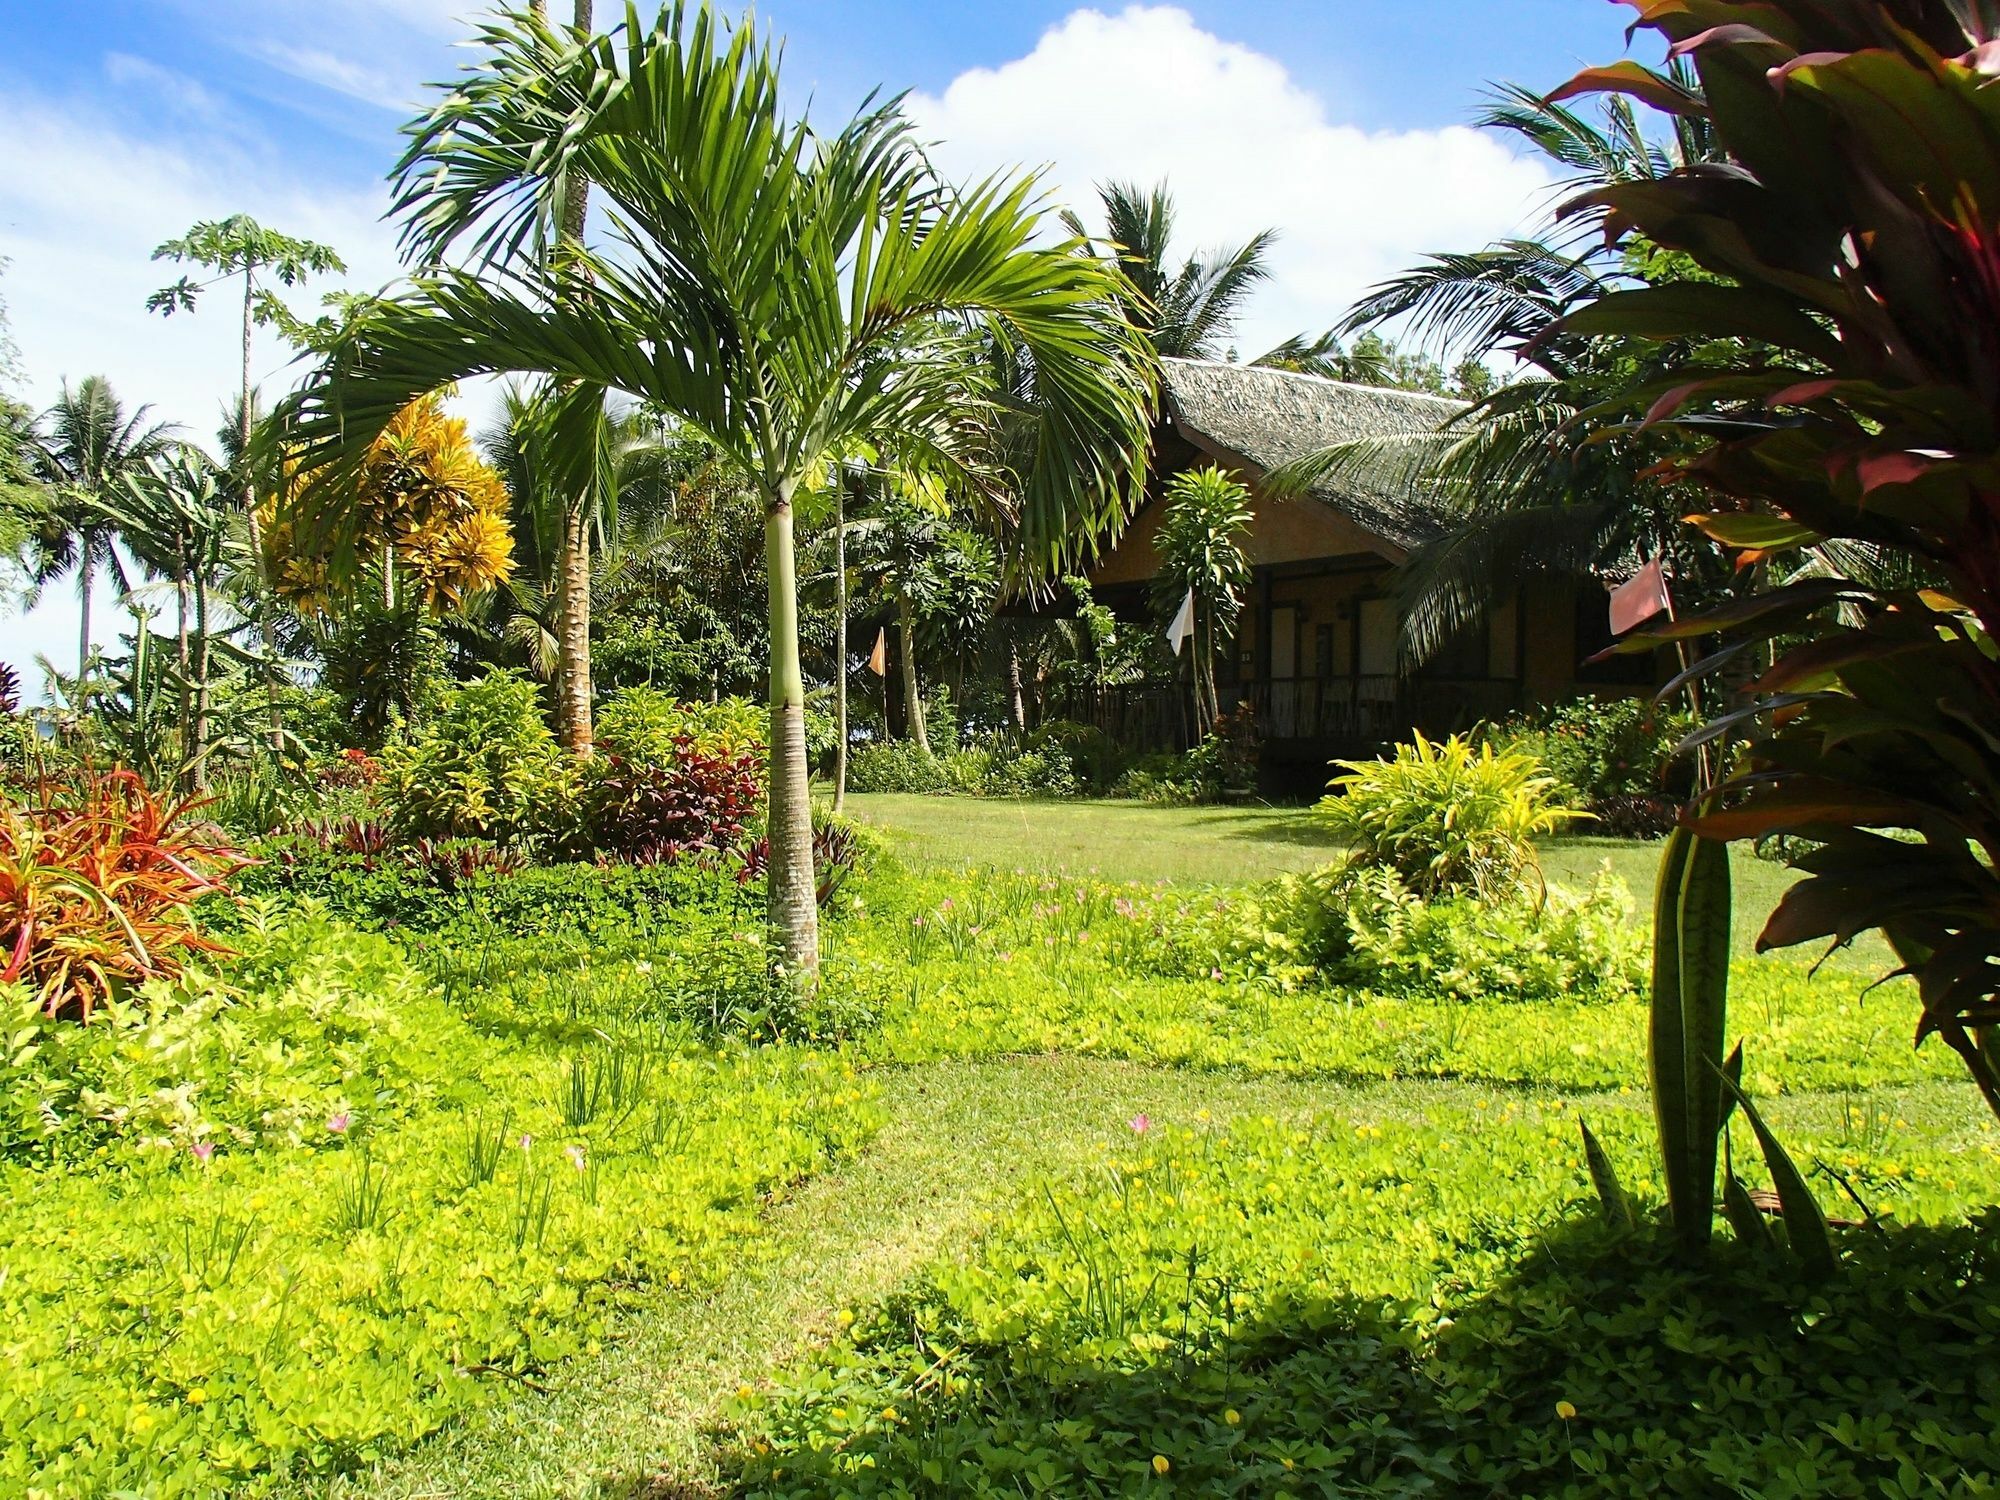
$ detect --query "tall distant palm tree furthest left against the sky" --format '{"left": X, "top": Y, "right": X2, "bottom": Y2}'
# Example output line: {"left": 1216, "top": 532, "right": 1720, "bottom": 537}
{"left": 30, "top": 376, "right": 174, "bottom": 676}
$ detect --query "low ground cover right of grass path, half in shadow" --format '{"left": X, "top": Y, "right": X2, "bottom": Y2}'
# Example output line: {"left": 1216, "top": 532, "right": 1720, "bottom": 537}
{"left": 734, "top": 1120, "right": 2000, "bottom": 1500}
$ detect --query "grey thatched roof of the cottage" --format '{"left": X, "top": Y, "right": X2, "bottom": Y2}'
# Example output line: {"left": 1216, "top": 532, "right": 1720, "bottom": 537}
{"left": 1160, "top": 360, "right": 1464, "bottom": 548}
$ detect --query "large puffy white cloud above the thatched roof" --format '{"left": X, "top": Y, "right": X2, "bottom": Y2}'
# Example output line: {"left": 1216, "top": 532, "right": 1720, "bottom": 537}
{"left": 910, "top": 4, "right": 1550, "bottom": 358}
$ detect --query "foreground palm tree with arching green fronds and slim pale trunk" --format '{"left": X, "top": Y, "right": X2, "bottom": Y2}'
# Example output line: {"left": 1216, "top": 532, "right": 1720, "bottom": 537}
{"left": 288, "top": 4, "right": 1152, "bottom": 974}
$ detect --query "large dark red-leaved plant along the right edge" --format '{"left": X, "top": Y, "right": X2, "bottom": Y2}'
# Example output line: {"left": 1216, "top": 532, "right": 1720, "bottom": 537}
{"left": 1558, "top": 0, "right": 2000, "bottom": 1112}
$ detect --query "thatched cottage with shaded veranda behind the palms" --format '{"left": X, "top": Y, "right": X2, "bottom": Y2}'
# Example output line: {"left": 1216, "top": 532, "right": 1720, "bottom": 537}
{"left": 1084, "top": 360, "right": 1652, "bottom": 776}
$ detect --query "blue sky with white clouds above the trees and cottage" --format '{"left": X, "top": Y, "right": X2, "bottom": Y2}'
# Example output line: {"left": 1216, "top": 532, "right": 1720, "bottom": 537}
{"left": 0, "top": 0, "right": 1630, "bottom": 680}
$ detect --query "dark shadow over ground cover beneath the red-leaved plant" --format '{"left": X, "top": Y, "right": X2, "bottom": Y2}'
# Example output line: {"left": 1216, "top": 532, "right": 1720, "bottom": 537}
{"left": 700, "top": 1216, "right": 2000, "bottom": 1500}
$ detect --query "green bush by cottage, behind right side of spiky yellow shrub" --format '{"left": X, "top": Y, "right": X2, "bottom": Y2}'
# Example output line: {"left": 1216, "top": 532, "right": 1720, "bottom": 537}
{"left": 1484, "top": 698, "right": 1696, "bottom": 838}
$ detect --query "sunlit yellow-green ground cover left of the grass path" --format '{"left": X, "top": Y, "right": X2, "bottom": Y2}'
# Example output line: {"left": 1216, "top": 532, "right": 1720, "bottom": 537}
{"left": 0, "top": 918, "right": 876, "bottom": 1500}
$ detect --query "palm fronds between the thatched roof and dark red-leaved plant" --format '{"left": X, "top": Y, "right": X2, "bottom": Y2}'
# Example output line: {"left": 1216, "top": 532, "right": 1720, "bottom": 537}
{"left": 1272, "top": 64, "right": 1716, "bottom": 662}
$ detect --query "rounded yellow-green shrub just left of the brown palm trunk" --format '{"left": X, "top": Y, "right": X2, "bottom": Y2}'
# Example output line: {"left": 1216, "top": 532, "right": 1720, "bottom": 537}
{"left": 382, "top": 670, "right": 576, "bottom": 844}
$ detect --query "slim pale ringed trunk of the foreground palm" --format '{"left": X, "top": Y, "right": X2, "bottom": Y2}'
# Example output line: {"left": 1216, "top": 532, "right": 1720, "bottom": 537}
{"left": 764, "top": 480, "right": 820, "bottom": 984}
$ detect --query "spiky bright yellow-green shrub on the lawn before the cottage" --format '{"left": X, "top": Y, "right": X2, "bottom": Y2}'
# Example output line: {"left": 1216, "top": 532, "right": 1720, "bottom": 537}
{"left": 1318, "top": 732, "right": 1578, "bottom": 898}
